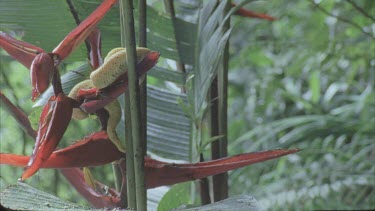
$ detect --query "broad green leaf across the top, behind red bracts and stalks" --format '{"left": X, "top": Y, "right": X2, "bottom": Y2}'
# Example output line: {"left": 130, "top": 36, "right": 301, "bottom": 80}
{"left": 0, "top": 0, "right": 197, "bottom": 64}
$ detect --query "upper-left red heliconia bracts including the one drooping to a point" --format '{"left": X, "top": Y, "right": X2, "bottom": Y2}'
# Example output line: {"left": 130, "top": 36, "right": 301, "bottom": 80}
{"left": 0, "top": 0, "right": 117, "bottom": 179}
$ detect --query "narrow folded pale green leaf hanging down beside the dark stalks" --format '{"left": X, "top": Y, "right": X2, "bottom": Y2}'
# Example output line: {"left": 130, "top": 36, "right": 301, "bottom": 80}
{"left": 194, "top": 1, "right": 231, "bottom": 115}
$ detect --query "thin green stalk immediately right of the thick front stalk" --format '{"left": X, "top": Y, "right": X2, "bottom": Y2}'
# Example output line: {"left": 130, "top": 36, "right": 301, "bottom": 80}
{"left": 138, "top": 0, "right": 147, "bottom": 156}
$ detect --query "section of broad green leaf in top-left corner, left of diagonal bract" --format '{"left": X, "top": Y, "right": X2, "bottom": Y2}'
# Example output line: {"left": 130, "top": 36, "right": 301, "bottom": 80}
{"left": 0, "top": 0, "right": 87, "bottom": 61}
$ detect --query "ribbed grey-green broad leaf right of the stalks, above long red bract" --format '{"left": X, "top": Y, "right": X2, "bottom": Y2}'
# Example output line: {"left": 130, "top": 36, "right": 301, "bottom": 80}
{"left": 117, "top": 86, "right": 191, "bottom": 160}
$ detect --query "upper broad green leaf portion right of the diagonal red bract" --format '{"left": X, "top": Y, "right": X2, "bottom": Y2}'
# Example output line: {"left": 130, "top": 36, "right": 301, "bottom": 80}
{"left": 74, "top": 0, "right": 196, "bottom": 64}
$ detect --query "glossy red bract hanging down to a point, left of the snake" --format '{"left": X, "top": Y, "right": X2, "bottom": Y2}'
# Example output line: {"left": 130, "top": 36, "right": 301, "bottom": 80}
{"left": 21, "top": 93, "right": 75, "bottom": 180}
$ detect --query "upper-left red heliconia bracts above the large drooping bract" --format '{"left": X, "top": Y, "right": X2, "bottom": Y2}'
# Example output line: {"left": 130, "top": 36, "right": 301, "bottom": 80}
{"left": 0, "top": 0, "right": 117, "bottom": 101}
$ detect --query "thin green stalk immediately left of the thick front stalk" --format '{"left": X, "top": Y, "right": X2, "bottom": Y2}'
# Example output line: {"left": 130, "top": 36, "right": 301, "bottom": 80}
{"left": 120, "top": 1, "right": 136, "bottom": 209}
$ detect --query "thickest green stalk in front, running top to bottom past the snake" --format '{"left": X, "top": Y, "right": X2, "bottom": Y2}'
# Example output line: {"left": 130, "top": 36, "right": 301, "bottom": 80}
{"left": 121, "top": 0, "right": 147, "bottom": 211}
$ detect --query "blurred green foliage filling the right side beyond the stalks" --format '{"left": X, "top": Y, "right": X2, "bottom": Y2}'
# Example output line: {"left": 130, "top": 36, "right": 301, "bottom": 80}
{"left": 229, "top": 1, "right": 375, "bottom": 210}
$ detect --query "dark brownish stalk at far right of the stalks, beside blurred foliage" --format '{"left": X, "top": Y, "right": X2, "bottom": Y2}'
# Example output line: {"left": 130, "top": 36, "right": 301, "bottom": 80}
{"left": 211, "top": 0, "right": 231, "bottom": 202}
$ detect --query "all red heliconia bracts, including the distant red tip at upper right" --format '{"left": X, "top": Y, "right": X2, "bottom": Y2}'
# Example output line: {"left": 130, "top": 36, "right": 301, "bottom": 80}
{"left": 0, "top": 0, "right": 298, "bottom": 208}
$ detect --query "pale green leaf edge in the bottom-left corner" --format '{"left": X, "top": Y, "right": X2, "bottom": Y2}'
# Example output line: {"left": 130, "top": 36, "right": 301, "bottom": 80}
{"left": 0, "top": 182, "right": 89, "bottom": 210}
